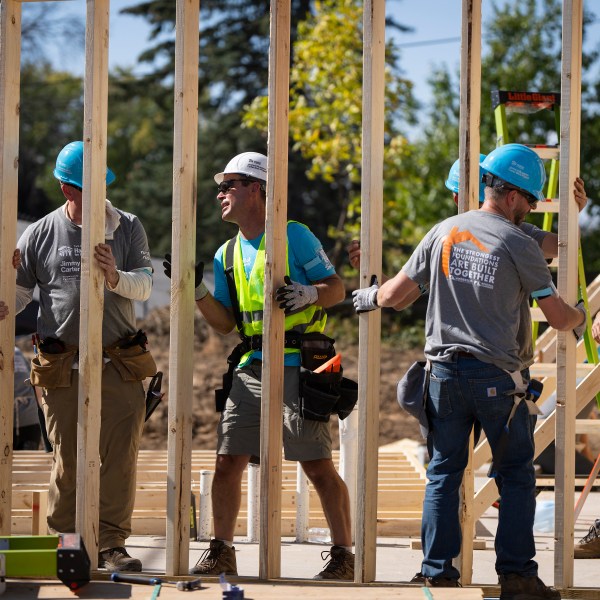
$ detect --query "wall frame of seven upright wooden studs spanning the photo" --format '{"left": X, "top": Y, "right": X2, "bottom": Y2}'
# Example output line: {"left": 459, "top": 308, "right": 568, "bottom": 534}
{"left": 0, "top": 0, "right": 600, "bottom": 588}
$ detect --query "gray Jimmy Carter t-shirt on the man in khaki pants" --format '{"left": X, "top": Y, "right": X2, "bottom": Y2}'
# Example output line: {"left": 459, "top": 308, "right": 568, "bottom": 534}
{"left": 17, "top": 207, "right": 152, "bottom": 346}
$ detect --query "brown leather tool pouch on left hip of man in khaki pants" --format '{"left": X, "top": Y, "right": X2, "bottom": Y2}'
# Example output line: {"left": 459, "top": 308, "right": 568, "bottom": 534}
{"left": 29, "top": 338, "right": 77, "bottom": 390}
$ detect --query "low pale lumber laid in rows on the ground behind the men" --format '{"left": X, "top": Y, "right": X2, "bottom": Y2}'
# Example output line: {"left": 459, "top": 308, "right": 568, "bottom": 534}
{"left": 11, "top": 444, "right": 426, "bottom": 537}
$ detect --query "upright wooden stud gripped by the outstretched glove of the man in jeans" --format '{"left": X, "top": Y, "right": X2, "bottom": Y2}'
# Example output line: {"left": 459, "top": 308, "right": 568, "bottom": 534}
{"left": 354, "top": 0, "right": 385, "bottom": 583}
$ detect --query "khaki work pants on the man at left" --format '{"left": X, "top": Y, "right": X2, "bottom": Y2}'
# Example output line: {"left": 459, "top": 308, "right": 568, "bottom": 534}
{"left": 42, "top": 362, "right": 145, "bottom": 551}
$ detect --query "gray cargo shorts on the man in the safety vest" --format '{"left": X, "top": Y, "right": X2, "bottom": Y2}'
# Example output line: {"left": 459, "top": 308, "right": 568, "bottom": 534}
{"left": 217, "top": 360, "right": 331, "bottom": 462}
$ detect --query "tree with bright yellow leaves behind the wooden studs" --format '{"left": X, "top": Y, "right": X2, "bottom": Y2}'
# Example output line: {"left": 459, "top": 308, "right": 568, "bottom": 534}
{"left": 244, "top": 0, "right": 416, "bottom": 265}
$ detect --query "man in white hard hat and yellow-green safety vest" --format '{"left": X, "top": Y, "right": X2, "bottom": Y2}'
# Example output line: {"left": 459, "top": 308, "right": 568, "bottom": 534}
{"left": 165, "top": 152, "right": 354, "bottom": 580}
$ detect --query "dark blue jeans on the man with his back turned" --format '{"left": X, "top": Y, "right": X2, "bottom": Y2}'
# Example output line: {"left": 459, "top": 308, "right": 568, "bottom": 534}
{"left": 421, "top": 355, "right": 537, "bottom": 579}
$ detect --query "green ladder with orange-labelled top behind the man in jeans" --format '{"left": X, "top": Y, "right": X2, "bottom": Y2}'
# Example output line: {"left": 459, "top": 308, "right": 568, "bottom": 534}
{"left": 492, "top": 90, "right": 600, "bottom": 407}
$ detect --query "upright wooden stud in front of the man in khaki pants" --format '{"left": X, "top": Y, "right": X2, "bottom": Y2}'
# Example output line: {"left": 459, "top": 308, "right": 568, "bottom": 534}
{"left": 75, "top": 0, "right": 109, "bottom": 569}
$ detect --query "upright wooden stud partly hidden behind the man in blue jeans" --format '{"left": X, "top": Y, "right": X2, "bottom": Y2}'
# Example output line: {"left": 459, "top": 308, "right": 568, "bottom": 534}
{"left": 454, "top": 0, "right": 481, "bottom": 585}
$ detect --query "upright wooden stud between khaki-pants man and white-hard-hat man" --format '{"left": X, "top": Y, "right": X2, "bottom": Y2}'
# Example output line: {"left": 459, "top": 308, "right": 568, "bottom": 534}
{"left": 166, "top": 0, "right": 200, "bottom": 575}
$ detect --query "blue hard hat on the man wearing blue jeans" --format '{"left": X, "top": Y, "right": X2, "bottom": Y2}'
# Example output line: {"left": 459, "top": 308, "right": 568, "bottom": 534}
{"left": 480, "top": 144, "right": 546, "bottom": 200}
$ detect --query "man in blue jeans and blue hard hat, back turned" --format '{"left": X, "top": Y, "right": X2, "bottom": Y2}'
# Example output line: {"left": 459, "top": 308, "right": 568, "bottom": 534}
{"left": 354, "top": 144, "right": 586, "bottom": 600}
